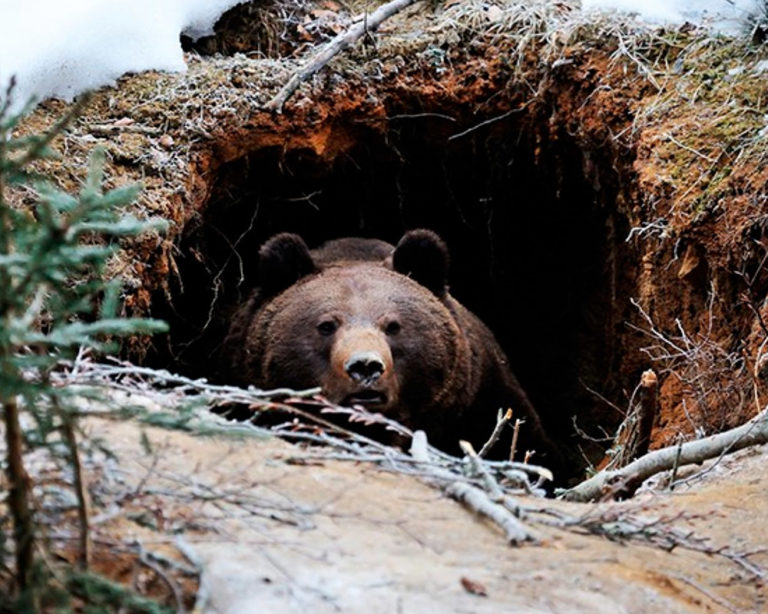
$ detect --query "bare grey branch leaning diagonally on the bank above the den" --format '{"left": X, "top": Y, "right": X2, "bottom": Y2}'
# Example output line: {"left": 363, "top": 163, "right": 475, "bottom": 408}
{"left": 264, "top": 0, "right": 416, "bottom": 113}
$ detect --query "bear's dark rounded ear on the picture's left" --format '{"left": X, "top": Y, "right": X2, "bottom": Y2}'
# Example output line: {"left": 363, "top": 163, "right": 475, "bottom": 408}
{"left": 259, "top": 232, "right": 317, "bottom": 296}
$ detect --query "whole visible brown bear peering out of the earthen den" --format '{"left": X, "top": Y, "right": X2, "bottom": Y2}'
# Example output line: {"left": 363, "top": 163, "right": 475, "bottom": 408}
{"left": 224, "top": 230, "right": 556, "bottom": 463}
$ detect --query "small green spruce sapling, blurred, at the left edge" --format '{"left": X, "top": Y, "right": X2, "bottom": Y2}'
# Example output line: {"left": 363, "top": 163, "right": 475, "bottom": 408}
{"left": 0, "top": 87, "right": 166, "bottom": 610}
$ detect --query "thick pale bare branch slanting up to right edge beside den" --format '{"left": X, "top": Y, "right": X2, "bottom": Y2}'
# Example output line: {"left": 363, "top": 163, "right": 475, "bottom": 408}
{"left": 562, "top": 410, "right": 768, "bottom": 501}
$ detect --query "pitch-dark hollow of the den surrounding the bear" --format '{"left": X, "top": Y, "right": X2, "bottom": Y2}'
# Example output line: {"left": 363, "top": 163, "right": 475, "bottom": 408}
{"left": 150, "top": 108, "right": 632, "bottom": 462}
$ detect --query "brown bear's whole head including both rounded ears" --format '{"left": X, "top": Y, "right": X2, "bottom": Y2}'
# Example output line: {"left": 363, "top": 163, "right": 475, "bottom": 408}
{"left": 243, "top": 230, "right": 474, "bottom": 428}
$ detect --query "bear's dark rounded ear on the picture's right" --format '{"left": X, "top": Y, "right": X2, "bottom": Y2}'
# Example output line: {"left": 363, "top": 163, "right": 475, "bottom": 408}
{"left": 392, "top": 229, "right": 450, "bottom": 297}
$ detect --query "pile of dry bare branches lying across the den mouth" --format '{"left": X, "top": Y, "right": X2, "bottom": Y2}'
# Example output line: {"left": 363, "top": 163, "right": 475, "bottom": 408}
{"left": 52, "top": 356, "right": 768, "bottom": 580}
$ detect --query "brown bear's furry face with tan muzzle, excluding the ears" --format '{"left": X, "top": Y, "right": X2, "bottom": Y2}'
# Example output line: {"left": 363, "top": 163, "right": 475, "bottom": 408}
{"left": 248, "top": 263, "right": 470, "bottom": 423}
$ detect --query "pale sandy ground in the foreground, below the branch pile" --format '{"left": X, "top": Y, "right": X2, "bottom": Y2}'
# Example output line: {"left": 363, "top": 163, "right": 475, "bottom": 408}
{"left": 81, "top": 421, "right": 768, "bottom": 614}
